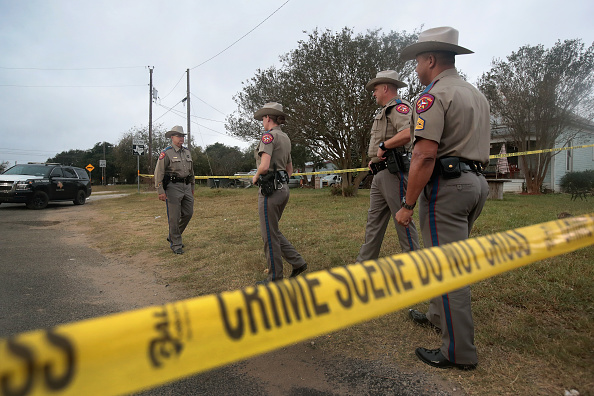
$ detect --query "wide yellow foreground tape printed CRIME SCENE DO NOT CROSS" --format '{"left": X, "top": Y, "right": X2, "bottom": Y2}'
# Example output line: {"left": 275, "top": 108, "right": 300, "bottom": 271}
{"left": 0, "top": 213, "right": 594, "bottom": 396}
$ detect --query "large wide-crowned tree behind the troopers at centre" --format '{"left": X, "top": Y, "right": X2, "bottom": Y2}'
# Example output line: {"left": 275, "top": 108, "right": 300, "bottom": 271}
{"left": 226, "top": 28, "right": 421, "bottom": 195}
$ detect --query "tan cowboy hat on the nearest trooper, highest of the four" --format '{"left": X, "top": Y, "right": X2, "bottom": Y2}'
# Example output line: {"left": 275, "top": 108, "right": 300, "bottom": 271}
{"left": 400, "top": 26, "right": 474, "bottom": 60}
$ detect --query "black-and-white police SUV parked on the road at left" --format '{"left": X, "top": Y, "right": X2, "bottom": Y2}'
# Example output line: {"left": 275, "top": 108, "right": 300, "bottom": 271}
{"left": 0, "top": 163, "right": 91, "bottom": 209}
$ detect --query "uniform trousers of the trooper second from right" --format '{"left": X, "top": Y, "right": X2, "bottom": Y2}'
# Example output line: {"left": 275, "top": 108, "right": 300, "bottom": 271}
{"left": 357, "top": 169, "right": 419, "bottom": 261}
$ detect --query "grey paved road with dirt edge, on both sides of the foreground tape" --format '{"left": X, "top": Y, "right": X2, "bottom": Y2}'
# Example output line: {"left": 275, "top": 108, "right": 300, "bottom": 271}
{"left": 0, "top": 200, "right": 460, "bottom": 396}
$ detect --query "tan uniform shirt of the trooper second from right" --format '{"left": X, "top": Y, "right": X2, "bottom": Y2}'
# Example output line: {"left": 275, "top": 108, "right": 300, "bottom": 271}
{"left": 367, "top": 97, "right": 411, "bottom": 162}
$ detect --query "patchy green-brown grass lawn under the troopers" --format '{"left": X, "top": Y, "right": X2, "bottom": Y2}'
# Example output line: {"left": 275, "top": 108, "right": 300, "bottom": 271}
{"left": 86, "top": 185, "right": 594, "bottom": 395}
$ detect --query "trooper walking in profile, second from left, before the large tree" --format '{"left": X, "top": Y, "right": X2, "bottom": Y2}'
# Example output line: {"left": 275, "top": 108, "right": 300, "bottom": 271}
{"left": 252, "top": 102, "right": 307, "bottom": 284}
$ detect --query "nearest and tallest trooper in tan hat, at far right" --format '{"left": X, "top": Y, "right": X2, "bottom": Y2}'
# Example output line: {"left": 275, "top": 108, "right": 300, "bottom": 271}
{"left": 396, "top": 27, "right": 490, "bottom": 370}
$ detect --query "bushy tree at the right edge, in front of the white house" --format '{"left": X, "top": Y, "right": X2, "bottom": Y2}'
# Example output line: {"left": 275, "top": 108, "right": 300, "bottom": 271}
{"left": 478, "top": 39, "right": 594, "bottom": 193}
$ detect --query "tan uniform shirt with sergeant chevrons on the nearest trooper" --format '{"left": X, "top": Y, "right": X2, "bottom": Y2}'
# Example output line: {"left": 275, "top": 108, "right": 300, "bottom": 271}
{"left": 412, "top": 69, "right": 491, "bottom": 165}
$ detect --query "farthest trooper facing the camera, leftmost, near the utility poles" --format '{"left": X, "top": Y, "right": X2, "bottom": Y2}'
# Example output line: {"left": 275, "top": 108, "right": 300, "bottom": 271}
{"left": 155, "top": 125, "right": 196, "bottom": 254}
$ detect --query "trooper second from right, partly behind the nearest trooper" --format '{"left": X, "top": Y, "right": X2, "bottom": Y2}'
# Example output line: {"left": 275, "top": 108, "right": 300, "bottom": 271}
{"left": 357, "top": 70, "right": 419, "bottom": 261}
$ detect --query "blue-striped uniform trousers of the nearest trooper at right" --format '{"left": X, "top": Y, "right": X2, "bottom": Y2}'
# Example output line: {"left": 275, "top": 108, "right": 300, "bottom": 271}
{"left": 419, "top": 172, "right": 489, "bottom": 364}
